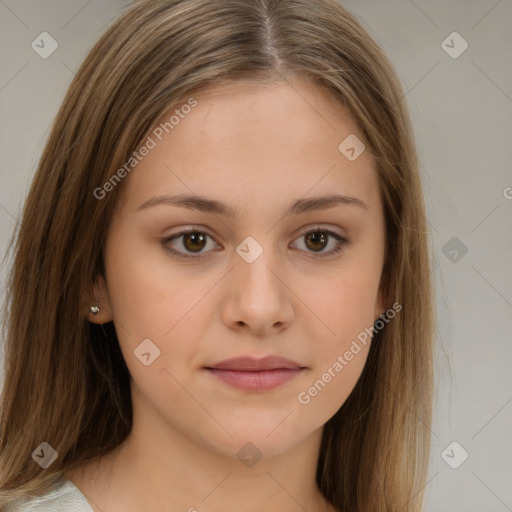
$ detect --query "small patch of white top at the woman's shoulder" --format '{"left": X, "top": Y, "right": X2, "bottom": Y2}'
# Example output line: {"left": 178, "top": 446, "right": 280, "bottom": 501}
{"left": 2, "top": 476, "right": 93, "bottom": 512}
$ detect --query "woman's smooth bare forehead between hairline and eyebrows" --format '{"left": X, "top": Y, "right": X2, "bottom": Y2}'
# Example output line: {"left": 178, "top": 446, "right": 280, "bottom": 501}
{"left": 116, "top": 80, "right": 377, "bottom": 214}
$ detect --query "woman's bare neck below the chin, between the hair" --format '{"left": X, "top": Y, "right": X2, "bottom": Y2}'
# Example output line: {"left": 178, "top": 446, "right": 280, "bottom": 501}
{"left": 66, "top": 390, "right": 334, "bottom": 512}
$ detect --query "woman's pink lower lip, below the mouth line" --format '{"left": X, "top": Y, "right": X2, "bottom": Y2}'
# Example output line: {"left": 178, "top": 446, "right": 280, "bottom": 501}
{"left": 208, "top": 368, "right": 304, "bottom": 391}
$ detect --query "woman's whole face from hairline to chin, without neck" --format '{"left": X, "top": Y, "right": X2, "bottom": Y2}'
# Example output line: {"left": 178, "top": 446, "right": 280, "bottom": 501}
{"left": 91, "top": 81, "right": 385, "bottom": 457}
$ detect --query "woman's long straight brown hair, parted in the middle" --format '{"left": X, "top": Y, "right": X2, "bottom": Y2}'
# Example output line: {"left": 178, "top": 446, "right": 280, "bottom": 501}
{"left": 0, "top": 0, "right": 433, "bottom": 512}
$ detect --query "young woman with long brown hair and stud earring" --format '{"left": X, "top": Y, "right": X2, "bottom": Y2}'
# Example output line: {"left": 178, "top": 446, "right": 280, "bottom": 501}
{"left": 0, "top": 0, "right": 432, "bottom": 512}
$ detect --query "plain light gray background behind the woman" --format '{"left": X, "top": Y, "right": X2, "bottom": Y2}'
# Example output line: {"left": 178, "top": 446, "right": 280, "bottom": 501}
{"left": 0, "top": 0, "right": 512, "bottom": 512}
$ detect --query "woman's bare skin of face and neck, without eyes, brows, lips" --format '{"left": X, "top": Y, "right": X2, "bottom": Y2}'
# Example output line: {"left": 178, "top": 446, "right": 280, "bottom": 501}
{"left": 67, "top": 79, "right": 386, "bottom": 512}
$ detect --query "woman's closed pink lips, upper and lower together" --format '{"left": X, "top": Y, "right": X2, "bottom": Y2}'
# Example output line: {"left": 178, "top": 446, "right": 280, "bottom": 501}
{"left": 206, "top": 356, "right": 305, "bottom": 391}
